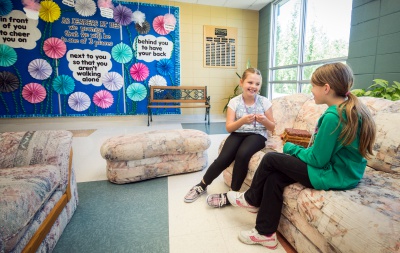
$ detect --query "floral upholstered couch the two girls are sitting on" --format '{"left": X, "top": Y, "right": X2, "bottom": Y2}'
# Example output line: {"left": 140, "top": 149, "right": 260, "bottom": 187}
{"left": 220, "top": 94, "right": 400, "bottom": 253}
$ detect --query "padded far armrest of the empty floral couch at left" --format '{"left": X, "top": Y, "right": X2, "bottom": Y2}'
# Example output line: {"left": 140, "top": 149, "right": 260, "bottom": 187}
{"left": 0, "top": 130, "right": 72, "bottom": 190}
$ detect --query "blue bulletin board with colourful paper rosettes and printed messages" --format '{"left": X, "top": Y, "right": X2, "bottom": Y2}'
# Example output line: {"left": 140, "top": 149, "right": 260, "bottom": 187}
{"left": 0, "top": 0, "right": 180, "bottom": 118}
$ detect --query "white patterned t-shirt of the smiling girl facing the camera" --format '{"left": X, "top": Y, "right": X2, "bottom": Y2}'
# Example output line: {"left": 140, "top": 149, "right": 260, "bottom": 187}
{"left": 228, "top": 95, "right": 272, "bottom": 138}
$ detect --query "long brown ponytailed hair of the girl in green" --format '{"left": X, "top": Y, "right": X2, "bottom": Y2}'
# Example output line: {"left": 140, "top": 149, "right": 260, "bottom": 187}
{"left": 311, "top": 62, "right": 376, "bottom": 158}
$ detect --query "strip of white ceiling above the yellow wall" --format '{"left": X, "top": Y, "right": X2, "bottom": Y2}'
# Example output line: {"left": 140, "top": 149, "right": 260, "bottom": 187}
{"left": 169, "top": 0, "right": 273, "bottom": 11}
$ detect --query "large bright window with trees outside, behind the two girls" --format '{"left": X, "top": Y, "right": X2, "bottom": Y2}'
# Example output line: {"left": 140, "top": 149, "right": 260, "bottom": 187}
{"left": 268, "top": 0, "right": 352, "bottom": 99}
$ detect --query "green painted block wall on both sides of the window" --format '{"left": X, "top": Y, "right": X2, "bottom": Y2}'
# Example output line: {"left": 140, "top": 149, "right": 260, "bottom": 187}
{"left": 258, "top": 0, "right": 400, "bottom": 91}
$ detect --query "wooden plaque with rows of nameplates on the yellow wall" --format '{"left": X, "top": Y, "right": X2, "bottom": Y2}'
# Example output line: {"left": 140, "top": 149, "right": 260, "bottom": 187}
{"left": 203, "top": 25, "right": 238, "bottom": 68}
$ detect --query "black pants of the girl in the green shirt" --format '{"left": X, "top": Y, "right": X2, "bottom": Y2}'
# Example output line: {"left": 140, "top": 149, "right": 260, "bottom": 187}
{"left": 244, "top": 152, "right": 313, "bottom": 235}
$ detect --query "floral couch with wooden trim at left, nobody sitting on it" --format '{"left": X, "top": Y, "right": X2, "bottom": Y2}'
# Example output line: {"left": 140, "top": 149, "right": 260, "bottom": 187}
{"left": 0, "top": 130, "right": 78, "bottom": 252}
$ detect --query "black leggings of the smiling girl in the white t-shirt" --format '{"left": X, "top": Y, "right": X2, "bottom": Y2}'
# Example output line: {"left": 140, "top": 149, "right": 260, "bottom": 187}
{"left": 203, "top": 132, "right": 267, "bottom": 191}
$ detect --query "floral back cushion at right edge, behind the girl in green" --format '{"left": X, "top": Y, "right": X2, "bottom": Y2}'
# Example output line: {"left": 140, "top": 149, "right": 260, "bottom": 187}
{"left": 368, "top": 112, "right": 400, "bottom": 173}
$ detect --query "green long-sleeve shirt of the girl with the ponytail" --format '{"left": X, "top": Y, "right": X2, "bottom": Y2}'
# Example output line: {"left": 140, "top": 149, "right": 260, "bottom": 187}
{"left": 283, "top": 105, "right": 367, "bottom": 190}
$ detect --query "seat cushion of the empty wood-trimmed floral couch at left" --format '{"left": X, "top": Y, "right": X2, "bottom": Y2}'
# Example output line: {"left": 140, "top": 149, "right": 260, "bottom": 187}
{"left": 0, "top": 165, "right": 61, "bottom": 252}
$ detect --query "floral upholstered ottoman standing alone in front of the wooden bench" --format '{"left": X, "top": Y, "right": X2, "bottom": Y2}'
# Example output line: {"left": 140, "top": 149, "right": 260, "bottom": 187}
{"left": 100, "top": 129, "right": 211, "bottom": 184}
